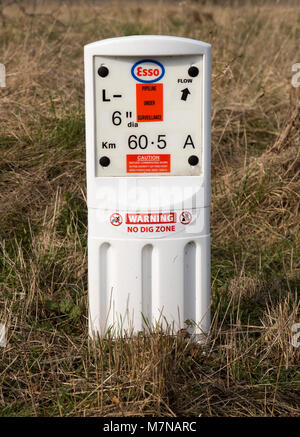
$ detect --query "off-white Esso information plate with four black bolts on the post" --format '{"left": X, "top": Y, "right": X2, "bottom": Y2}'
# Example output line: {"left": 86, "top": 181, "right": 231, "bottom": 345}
{"left": 94, "top": 56, "right": 203, "bottom": 176}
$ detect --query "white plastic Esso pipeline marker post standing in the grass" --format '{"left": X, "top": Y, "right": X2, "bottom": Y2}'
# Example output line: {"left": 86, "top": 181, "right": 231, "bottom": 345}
{"left": 84, "top": 36, "right": 211, "bottom": 338}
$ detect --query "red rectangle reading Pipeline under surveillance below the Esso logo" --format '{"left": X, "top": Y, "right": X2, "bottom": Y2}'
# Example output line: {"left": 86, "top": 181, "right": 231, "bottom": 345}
{"left": 136, "top": 83, "right": 163, "bottom": 123}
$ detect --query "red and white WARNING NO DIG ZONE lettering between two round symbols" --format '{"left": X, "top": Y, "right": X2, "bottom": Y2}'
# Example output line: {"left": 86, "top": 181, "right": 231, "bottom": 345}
{"left": 126, "top": 212, "right": 177, "bottom": 233}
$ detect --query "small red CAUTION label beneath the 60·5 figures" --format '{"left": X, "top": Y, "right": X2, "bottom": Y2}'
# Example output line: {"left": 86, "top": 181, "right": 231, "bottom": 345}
{"left": 127, "top": 154, "right": 171, "bottom": 173}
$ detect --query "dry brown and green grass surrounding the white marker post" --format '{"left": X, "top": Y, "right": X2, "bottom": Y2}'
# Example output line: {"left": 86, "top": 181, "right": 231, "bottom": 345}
{"left": 0, "top": 0, "right": 300, "bottom": 416}
